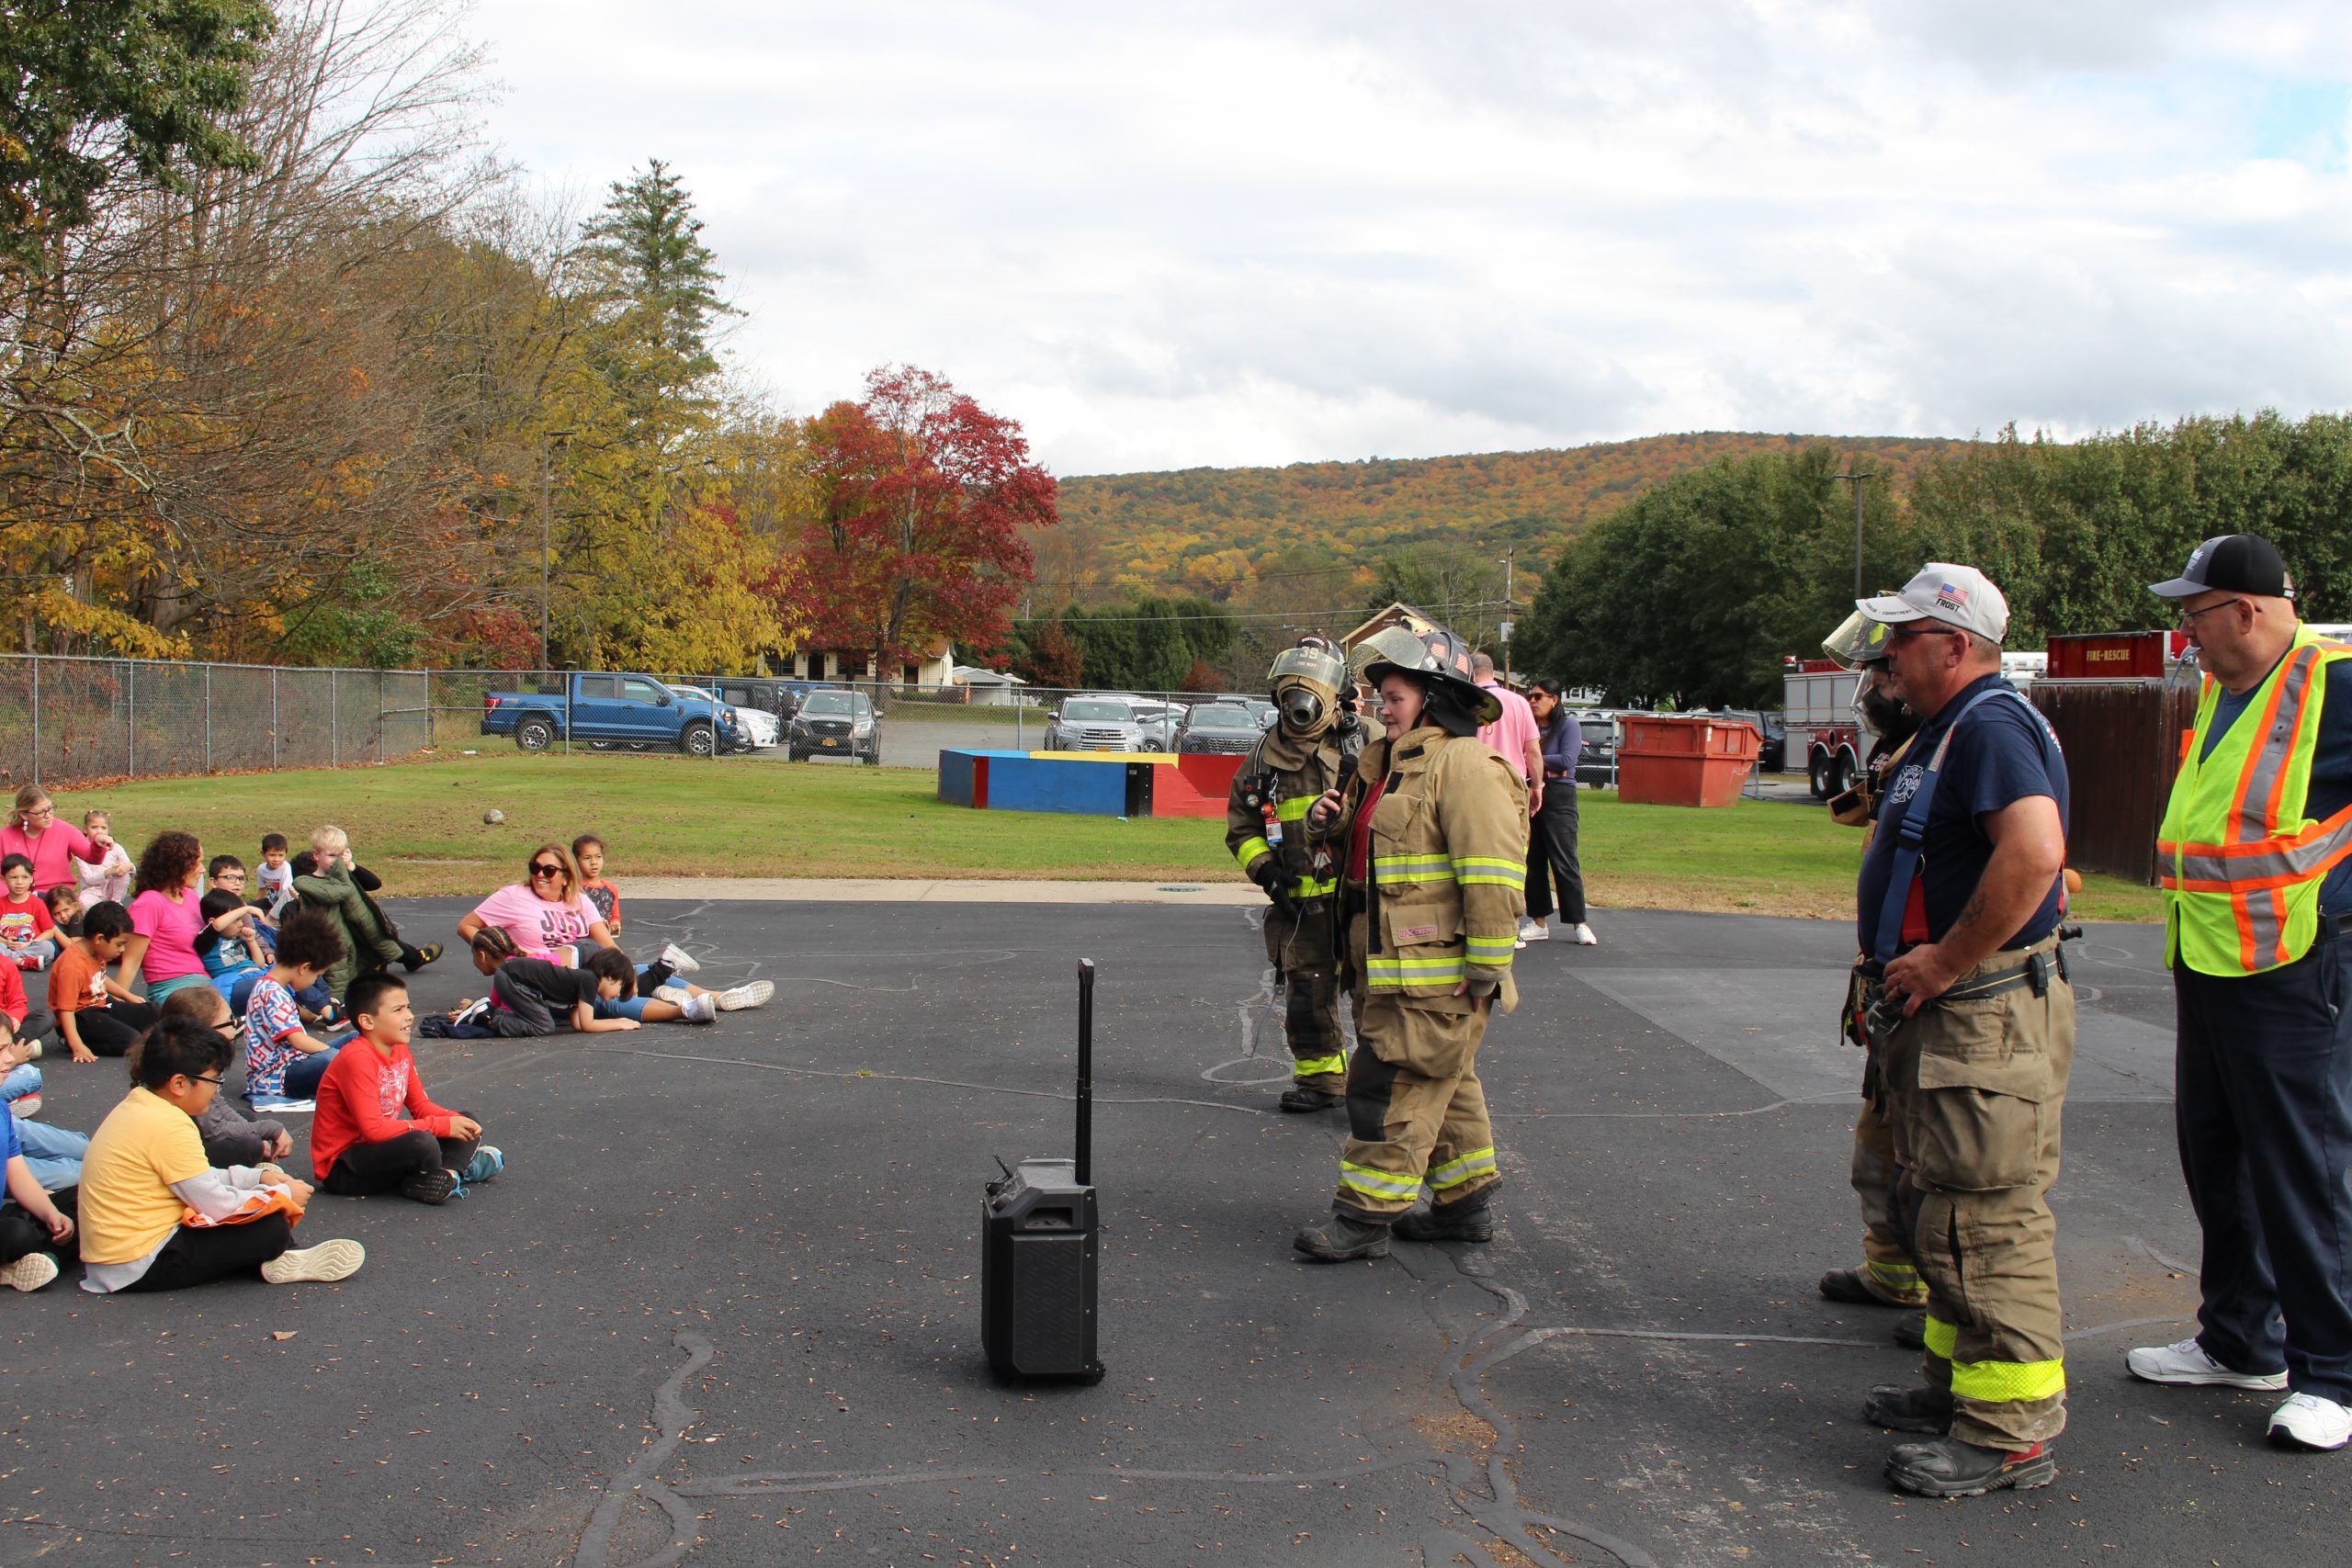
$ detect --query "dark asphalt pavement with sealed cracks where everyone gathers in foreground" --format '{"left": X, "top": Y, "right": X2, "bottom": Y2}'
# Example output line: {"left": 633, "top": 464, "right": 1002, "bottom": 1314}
{"left": 0, "top": 898, "right": 2352, "bottom": 1568}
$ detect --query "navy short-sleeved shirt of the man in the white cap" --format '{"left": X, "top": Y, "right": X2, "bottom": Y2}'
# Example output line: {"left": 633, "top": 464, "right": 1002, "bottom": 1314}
{"left": 1856, "top": 674, "right": 2067, "bottom": 952}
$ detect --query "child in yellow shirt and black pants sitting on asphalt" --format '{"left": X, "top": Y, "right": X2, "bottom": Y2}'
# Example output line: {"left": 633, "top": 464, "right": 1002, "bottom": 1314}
{"left": 77, "top": 1018, "right": 367, "bottom": 1295}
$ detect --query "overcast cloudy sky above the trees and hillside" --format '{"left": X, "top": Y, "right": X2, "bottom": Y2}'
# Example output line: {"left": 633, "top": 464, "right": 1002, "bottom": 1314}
{"left": 470, "top": 0, "right": 2352, "bottom": 472}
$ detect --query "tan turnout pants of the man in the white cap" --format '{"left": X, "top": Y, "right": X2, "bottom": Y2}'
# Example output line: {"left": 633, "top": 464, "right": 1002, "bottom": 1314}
{"left": 1879, "top": 936, "right": 2075, "bottom": 1450}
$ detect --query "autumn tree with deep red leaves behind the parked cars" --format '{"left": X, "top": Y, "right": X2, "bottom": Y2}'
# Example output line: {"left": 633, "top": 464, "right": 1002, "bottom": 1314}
{"left": 802, "top": 365, "right": 1061, "bottom": 672}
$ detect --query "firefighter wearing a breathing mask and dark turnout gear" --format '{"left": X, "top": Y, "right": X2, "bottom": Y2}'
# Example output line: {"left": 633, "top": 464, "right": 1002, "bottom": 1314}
{"left": 1226, "top": 637, "right": 1364, "bottom": 1112}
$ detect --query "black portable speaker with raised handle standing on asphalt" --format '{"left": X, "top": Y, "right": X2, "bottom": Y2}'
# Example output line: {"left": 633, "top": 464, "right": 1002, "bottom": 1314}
{"left": 981, "top": 959, "right": 1103, "bottom": 1382}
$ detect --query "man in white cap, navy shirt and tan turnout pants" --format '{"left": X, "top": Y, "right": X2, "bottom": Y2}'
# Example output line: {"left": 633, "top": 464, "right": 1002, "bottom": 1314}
{"left": 1856, "top": 562, "right": 2075, "bottom": 1497}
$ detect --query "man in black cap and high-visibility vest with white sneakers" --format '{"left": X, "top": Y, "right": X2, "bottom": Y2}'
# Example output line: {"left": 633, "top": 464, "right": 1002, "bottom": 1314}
{"left": 2124, "top": 534, "right": 2352, "bottom": 1450}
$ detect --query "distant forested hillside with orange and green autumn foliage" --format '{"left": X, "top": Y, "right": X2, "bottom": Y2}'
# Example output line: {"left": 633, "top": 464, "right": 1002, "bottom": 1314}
{"left": 1033, "top": 430, "right": 1969, "bottom": 606}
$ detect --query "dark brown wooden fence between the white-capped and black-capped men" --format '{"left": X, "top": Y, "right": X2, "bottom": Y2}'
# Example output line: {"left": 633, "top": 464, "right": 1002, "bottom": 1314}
{"left": 2028, "top": 680, "right": 2197, "bottom": 884}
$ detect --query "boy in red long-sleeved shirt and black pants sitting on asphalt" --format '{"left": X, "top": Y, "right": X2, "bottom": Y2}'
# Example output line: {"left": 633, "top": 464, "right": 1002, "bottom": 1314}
{"left": 311, "top": 971, "right": 505, "bottom": 1203}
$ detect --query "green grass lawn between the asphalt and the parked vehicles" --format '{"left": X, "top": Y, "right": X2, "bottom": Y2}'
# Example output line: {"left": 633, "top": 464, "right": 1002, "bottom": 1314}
{"left": 41, "top": 752, "right": 2159, "bottom": 919}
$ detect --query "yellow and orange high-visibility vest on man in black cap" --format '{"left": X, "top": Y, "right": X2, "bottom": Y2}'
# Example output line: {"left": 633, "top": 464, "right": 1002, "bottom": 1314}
{"left": 2157, "top": 627, "right": 2352, "bottom": 976}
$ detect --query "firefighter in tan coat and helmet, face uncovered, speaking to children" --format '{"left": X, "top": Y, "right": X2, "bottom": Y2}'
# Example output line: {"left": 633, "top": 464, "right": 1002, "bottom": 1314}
{"left": 1294, "top": 623, "right": 1526, "bottom": 1262}
